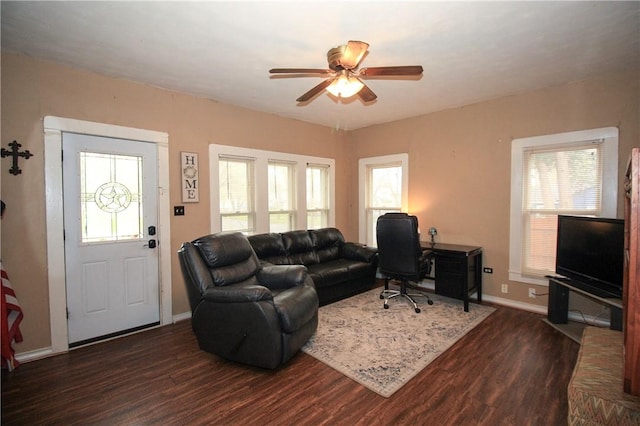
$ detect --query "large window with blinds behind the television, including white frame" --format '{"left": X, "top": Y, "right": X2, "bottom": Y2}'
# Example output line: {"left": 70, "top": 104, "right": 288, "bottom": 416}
{"left": 509, "top": 128, "right": 618, "bottom": 284}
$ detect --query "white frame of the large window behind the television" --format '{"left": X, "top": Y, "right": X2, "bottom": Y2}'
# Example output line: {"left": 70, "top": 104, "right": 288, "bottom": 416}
{"left": 509, "top": 127, "right": 618, "bottom": 286}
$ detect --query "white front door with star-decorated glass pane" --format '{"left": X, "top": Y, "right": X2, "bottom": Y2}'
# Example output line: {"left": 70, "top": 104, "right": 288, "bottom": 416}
{"left": 62, "top": 132, "right": 160, "bottom": 345}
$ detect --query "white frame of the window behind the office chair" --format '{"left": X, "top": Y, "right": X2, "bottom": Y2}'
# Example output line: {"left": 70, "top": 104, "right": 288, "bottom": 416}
{"left": 358, "top": 153, "right": 409, "bottom": 244}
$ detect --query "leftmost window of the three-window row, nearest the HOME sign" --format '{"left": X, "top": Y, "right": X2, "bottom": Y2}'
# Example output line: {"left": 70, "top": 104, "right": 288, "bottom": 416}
{"left": 218, "top": 157, "right": 255, "bottom": 234}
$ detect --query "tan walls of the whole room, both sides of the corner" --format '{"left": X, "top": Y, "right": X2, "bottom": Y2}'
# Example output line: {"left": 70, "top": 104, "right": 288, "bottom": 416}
{"left": 0, "top": 50, "right": 640, "bottom": 353}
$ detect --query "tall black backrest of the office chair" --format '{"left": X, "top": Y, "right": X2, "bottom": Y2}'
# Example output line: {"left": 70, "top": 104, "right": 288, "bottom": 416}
{"left": 376, "top": 213, "right": 422, "bottom": 278}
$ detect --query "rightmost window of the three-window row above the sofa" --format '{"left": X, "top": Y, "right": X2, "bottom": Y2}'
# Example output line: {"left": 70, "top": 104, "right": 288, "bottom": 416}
{"left": 307, "top": 164, "right": 329, "bottom": 229}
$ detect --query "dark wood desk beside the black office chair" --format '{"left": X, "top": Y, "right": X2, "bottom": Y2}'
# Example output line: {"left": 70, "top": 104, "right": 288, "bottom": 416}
{"left": 420, "top": 241, "right": 482, "bottom": 312}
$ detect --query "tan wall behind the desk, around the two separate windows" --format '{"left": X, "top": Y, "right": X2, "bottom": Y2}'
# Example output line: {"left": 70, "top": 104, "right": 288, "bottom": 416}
{"left": 349, "top": 71, "right": 640, "bottom": 306}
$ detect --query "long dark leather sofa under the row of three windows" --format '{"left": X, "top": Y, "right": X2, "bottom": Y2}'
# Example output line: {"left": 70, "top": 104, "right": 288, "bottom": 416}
{"left": 248, "top": 228, "right": 378, "bottom": 306}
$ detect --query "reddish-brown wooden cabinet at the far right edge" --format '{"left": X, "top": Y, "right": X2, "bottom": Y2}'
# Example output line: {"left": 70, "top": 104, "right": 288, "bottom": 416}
{"left": 622, "top": 148, "right": 640, "bottom": 395}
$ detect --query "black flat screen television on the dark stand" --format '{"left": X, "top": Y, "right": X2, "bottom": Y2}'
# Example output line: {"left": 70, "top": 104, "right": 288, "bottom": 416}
{"left": 556, "top": 215, "right": 624, "bottom": 298}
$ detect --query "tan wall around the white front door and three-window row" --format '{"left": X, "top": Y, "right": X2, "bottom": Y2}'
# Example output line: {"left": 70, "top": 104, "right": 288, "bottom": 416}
{"left": 0, "top": 54, "right": 350, "bottom": 353}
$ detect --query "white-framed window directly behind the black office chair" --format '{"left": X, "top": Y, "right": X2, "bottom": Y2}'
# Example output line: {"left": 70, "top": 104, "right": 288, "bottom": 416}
{"left": 359, "top": 154, "right": 409, "bottom": 246}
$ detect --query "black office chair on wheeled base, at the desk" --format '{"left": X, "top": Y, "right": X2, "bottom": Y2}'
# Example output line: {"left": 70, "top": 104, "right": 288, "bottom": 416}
{"left": 376, "top": 213, "right": 433, "bottom": 313}
